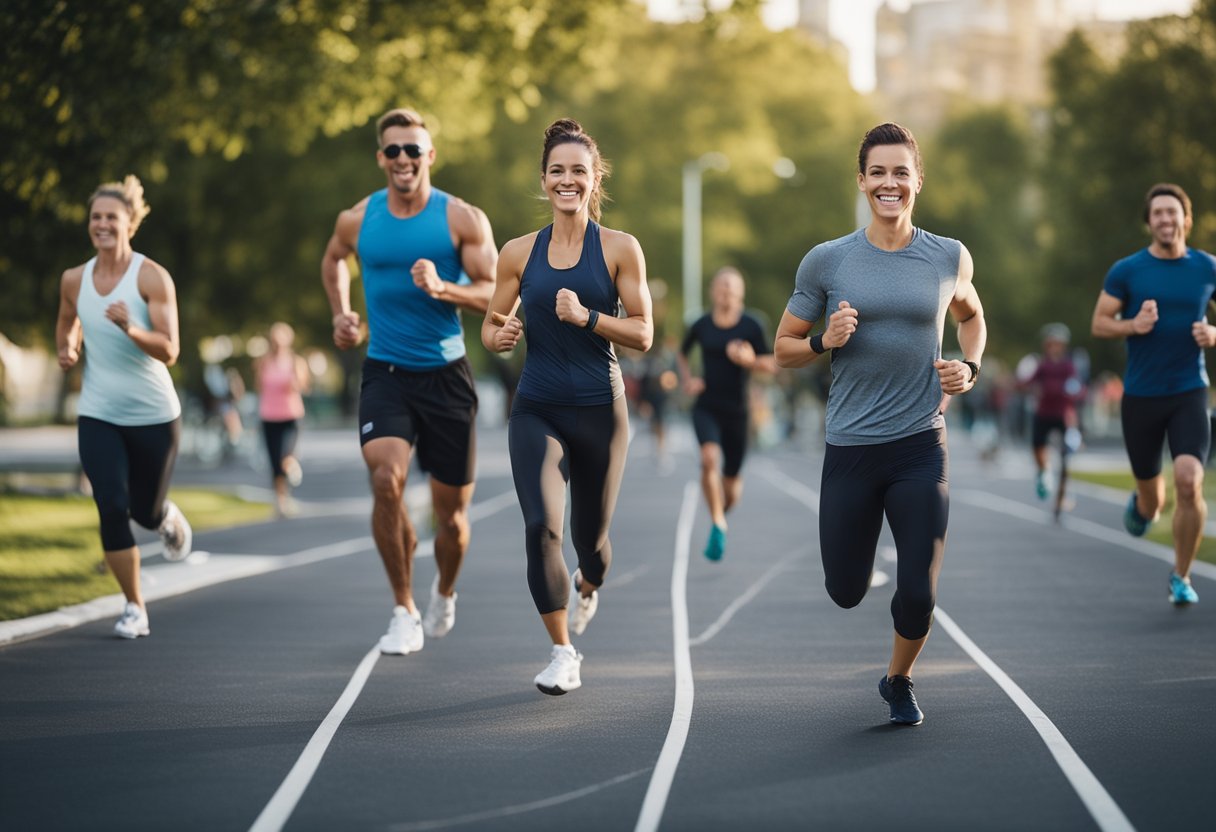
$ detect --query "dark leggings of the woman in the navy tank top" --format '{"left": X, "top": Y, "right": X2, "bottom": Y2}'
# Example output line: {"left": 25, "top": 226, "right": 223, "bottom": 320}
{"left": 507, "top": 395, "right": 629, "bottom": 615}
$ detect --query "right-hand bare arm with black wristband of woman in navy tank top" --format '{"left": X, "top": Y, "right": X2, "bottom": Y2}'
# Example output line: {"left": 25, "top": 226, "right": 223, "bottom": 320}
{"left": 557, "top": 229, "right": 654, "bottom": 353}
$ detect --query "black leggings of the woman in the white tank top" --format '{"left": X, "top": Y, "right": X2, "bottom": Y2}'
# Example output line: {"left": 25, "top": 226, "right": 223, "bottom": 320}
{"left": 77, "top": 416, "right": 181, "bottom": 552}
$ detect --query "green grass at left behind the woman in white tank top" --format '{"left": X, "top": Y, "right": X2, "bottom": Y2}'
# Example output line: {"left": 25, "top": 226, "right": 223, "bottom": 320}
{"left": 0, "top": 489, "right": 272, "bottom": 620}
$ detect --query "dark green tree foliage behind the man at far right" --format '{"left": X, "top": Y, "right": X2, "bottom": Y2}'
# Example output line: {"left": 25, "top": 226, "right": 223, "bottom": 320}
{"left": 1043, "top": 0, "right": 1216, "bottom": 370}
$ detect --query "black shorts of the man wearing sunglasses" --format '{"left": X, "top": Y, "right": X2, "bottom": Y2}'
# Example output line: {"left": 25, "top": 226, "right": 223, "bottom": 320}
{"left": 359, "top": 358, "right": 477, "bottom": 485}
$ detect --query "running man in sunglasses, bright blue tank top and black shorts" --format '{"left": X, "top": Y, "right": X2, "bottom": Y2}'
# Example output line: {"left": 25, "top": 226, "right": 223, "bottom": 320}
{"left": 321, "top": 109, "right": 497, "bottom": 656}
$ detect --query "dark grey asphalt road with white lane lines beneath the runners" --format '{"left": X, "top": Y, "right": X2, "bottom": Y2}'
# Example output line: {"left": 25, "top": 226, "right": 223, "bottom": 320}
{"left": 0, "top": 429, "right": 1216, "bottom": 831}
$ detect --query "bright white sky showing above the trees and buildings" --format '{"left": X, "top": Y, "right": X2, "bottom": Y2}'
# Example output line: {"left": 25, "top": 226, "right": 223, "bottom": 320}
{"left": 647, "top": 0, "right": 1194, "bottom": 92}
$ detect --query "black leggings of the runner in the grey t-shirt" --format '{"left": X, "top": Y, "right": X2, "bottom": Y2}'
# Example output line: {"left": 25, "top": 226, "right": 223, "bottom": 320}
{"left": 820, "top": 428, "right": 950, "bottom": 641}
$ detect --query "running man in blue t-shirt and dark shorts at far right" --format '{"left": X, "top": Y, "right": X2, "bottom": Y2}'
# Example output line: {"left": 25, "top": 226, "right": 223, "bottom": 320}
{"left": 1093, "top": 184, "right": 1216, "bottom": 606}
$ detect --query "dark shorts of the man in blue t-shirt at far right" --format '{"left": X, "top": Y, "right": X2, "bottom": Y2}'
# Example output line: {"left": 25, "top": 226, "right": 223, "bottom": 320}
{"left": 1121, "top": 387, "right": 1212, "bottom": 479}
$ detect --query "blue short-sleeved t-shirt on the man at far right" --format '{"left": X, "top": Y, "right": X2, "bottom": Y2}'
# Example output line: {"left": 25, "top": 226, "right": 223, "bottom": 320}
{"left": 1102, "top": 248, "right": 1216, "bottom": 395}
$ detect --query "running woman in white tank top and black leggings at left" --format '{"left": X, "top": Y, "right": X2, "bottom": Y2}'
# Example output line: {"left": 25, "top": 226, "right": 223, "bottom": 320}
{"left": 55, "top": 176, "right": 191, "bottom": 639}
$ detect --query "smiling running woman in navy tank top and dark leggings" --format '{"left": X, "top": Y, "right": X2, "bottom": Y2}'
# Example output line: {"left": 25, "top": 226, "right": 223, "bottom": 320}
{"left": 482, "top": 119, "right": 654, "bottom": 696}
